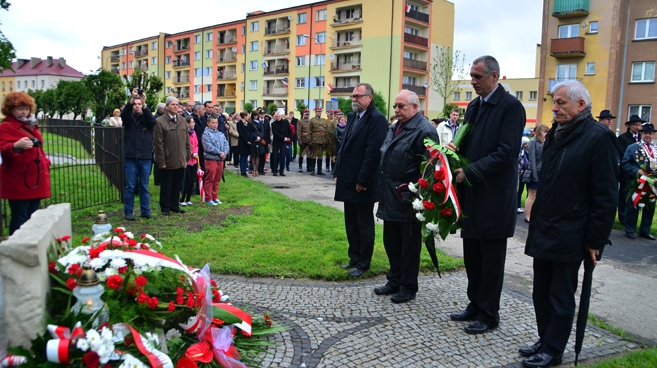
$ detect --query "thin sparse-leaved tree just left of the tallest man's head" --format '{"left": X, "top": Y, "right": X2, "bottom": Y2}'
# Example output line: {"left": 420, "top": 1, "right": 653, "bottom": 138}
{"left": 430, "top": 46, "right": 465, "bottom": 118}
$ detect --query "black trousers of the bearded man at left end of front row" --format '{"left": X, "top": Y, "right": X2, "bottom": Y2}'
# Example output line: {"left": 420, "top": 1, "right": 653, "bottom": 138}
{"left": 344, "top": 202, "right": 374, "bottom": 271}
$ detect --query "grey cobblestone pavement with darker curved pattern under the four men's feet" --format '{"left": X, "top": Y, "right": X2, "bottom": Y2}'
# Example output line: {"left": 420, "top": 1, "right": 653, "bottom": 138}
{"left": 215, "top": 272, "right": 636, "bottom": 368}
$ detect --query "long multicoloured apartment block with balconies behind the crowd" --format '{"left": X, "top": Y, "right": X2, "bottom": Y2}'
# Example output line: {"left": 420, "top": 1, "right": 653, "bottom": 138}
{"left": 101, "top": 0, "right": 454, "bottom": 115}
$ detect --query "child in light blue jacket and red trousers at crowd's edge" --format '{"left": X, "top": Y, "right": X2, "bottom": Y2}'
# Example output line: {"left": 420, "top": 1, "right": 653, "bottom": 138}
{"left": 202, "top": 116, "right": 230, "bottom": 206}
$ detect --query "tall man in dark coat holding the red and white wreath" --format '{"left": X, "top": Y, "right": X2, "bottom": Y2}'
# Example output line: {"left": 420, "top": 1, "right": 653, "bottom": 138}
{"left": 446, "top": 56, "right": 526, "bottom": 334}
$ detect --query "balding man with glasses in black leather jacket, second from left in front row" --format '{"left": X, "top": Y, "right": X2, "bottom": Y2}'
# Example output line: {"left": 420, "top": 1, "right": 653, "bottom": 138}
{"left": 372, "top": 90, "right": 439, "bottom": 303}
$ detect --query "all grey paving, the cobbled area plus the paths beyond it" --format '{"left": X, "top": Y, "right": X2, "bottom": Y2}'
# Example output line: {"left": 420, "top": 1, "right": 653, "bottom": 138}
{"left": 222, "top": 166, "right": 657, "bottom": 367}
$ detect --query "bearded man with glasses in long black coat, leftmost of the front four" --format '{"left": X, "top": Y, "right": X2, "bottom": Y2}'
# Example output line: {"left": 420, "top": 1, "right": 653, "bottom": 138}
{"left": 333, "top": 83, "right": 388, "bottom": 277}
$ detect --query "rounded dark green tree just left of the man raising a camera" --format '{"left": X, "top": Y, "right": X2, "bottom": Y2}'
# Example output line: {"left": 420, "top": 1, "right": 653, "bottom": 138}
{"left": 82, "top": 69, "right": 128, "bottom": 121}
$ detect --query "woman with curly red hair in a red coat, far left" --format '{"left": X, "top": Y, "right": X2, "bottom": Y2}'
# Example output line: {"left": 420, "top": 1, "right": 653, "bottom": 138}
{"left": 0, "top": 92, "right": 50, "bottom": 235}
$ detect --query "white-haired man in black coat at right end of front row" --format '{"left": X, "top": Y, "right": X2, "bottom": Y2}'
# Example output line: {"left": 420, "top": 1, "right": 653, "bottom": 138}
{"left": 519, "top": 80, "right": 618, "bottom": 368}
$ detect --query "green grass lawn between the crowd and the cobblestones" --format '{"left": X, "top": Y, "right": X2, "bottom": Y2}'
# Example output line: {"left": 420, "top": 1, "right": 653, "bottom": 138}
{"left": 72, "top": 172, "right": 463, "bottom": 281}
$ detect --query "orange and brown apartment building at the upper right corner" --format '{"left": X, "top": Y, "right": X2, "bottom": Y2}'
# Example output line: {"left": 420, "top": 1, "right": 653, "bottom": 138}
{"left": 538, "top": 0, "right": 657, "bottom": 133}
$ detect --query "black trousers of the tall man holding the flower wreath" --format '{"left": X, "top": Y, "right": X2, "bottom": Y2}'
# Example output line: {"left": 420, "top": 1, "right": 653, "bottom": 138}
{"left": 463, "top": 238, "right": 507, "bottom": 327}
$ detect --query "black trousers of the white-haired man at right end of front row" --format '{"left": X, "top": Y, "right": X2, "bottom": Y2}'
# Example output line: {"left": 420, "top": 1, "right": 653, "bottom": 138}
{"left": 532, "top": 258, "right": 581, "bottom": 356}
